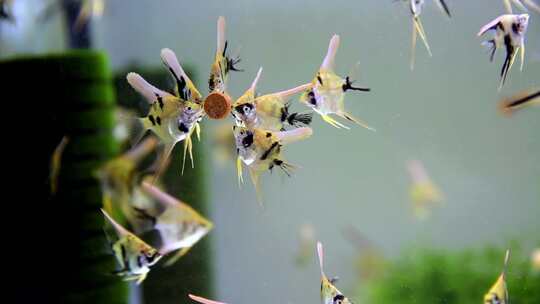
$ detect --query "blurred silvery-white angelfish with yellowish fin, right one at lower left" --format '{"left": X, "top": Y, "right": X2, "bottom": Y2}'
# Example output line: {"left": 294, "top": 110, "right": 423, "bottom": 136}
{"left": 136, "top": 182, "right": 213, "bottom": 266}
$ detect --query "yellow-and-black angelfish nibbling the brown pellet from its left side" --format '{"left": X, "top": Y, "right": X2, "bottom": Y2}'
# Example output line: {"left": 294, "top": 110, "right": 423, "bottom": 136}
{"left": 127, "top": 49, "right": 204, "bottom": 178}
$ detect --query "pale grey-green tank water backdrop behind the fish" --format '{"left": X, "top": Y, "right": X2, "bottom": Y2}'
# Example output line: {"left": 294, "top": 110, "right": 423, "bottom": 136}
{"left": 0, "top": 0, "right": 540, "bottom": 304}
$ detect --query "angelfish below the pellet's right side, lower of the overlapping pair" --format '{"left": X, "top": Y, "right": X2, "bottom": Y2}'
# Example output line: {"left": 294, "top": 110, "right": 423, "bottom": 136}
{"left": 233, "top": 126, "right": 313, "bottom": 202}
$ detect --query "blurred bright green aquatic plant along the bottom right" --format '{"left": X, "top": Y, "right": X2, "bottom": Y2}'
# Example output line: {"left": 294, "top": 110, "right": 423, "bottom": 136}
{"left": 360, "top": 246, "right": 540, "bottom": 304}
